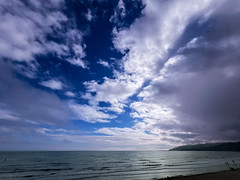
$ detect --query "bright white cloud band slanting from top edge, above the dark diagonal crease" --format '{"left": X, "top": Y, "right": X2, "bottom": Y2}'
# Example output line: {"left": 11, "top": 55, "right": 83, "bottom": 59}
{"left": 84, "top": 0, "right": 223, "bottom": 116}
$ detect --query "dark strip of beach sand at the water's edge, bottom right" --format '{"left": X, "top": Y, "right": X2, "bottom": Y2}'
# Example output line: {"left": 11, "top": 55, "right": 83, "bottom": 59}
{"left": 159, "top": 169, "right": 240, "bottom": 180}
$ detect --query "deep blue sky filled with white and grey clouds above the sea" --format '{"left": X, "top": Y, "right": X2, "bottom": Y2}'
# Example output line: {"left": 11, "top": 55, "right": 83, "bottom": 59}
{"left": 0, "top": 0, "right": 240, "bottom": 150}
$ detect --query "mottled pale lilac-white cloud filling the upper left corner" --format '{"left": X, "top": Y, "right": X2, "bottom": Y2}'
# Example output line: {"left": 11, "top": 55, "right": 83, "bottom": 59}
{"left": 0, "top": 0, "right": 67, "bottom": 61}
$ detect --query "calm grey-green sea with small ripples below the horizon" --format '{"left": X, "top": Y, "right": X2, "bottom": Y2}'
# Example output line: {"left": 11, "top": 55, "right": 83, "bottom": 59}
{"left": 0, "top": 151, "right": 240, "bottom": 180}
